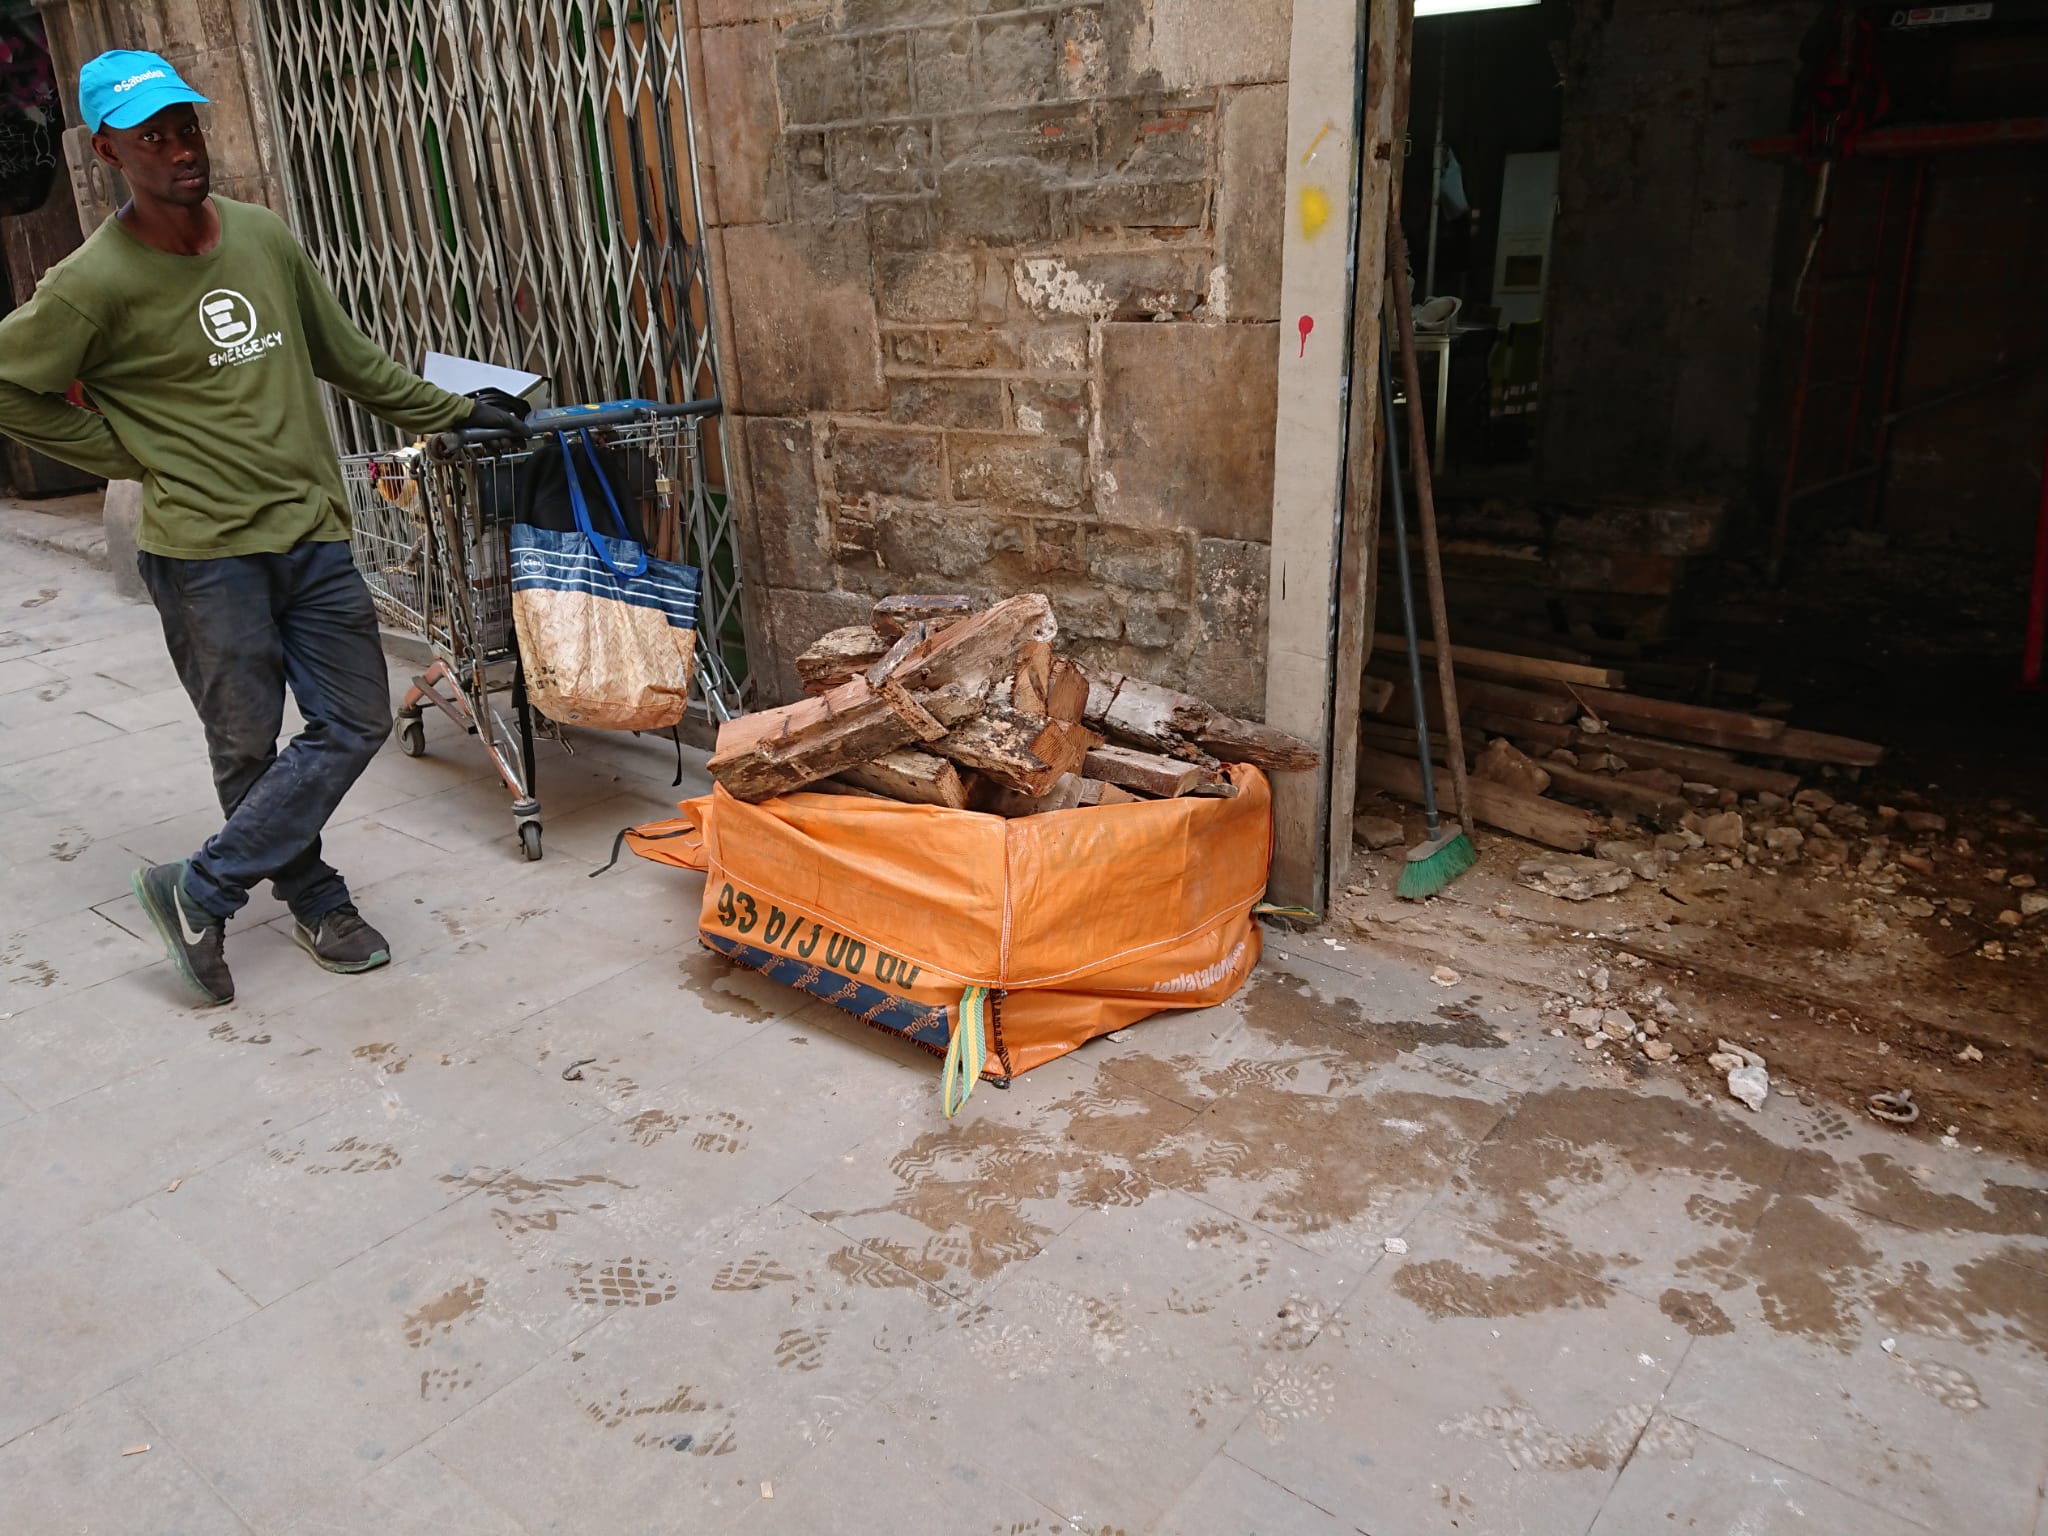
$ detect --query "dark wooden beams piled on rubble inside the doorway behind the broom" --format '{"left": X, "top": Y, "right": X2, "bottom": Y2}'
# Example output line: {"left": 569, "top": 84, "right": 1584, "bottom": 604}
{"left": 1358, "top": 635, "right": 1884, "bottom": 852}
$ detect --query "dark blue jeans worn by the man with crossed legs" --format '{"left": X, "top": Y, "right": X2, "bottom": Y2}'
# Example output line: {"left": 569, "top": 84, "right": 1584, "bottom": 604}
{"left": 139, "top": 543, "right": 391, "bottom": 926}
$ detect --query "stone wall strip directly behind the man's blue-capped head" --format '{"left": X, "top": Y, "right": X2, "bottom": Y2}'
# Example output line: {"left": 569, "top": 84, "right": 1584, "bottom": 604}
{"left": 41, "top": 0, "right": 285, "bottom": 229}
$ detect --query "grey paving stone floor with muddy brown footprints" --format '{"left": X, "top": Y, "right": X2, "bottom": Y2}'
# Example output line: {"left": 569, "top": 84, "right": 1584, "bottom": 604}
{"left": 0, "top": 547, "right": 2048, "bottom": 1536}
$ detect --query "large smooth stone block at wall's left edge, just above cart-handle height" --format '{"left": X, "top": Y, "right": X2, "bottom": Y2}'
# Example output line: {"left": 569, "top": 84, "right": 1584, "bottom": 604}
{"left": 719, "top": 221, "right": 887, "bottom": 416}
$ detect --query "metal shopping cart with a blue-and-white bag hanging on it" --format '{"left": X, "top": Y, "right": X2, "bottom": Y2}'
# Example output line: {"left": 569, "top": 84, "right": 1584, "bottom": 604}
{"left": 342, "top": 399, "right": 739, "bottom": 858}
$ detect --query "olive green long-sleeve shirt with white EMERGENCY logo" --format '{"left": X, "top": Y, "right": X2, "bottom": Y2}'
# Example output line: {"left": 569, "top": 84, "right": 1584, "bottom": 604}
{"left": 0, "top": 197, "right": 469, "bottom": 559}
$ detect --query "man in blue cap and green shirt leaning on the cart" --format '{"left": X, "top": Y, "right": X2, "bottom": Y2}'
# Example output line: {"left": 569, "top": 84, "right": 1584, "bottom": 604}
{"left": 0, "top": 51, "right": 520, "bottom": 1004}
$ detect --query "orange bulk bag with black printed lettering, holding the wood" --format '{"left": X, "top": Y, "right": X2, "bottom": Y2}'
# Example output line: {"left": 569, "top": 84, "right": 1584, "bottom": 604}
{"left": 627, "top": 764, "right": 1272, "bottom": 1112}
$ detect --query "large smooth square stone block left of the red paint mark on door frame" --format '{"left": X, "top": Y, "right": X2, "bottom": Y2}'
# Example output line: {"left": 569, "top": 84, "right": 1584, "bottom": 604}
{"left": 1098, "top": 326, "right": 1280, "bottom": 541}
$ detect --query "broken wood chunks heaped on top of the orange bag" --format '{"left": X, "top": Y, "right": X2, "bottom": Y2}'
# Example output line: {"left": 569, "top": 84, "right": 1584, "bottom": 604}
{"left": 711, "top": 592, "right": 1317, "bottom": 815}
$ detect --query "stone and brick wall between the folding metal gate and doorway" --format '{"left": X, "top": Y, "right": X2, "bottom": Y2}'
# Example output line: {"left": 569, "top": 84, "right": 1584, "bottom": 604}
{"left": 696, "top": 0, "right": 1290, "bottom": 715}
